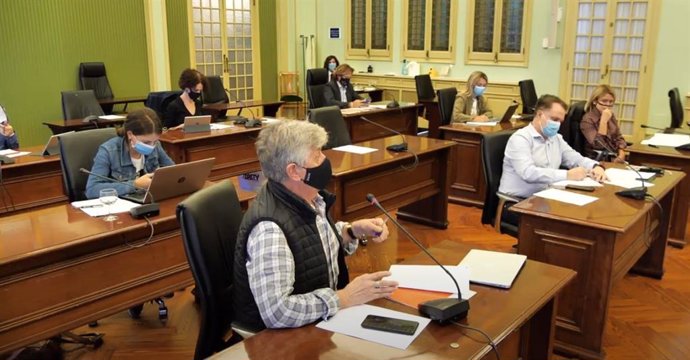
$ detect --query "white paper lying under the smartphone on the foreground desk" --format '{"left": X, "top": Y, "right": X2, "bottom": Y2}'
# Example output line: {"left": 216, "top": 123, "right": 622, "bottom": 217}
{"left": 316, "top": 304, "right": 431, "bottom": 350}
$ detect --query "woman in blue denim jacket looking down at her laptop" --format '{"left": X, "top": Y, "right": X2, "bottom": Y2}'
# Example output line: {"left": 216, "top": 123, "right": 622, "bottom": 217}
{"left": 86, "top": 108, "right": 175, "bottom": 199}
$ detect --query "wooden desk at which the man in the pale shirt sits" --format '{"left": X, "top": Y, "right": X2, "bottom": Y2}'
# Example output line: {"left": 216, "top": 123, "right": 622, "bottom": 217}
{"left": 511, "top": 165, "right": 685, "bottom": 359}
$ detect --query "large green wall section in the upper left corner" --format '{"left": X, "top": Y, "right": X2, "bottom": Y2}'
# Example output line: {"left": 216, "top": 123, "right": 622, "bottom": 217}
{"left": 0, "top": 0, "right": 149, "bottom": 146}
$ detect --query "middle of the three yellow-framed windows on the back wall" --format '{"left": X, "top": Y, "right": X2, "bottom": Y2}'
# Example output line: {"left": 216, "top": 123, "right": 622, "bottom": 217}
{"left": 403, "top": 0, "right": 456, "bottom": 61}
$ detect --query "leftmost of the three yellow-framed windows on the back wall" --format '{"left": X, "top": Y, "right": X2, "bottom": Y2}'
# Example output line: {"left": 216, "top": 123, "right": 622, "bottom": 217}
{"left": 345, "top": 0, "right": 393, "bottom": 60}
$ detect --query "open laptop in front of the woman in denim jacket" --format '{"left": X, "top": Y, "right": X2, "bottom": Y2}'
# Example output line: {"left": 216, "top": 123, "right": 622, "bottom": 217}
{"left": 120, "top": 158, "right": 216, "bottom": 204}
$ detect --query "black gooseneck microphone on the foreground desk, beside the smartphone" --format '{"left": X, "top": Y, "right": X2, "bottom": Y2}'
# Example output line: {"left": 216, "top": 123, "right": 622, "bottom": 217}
{"left": 367, "top": 194, "right": 470, "bottom": 323}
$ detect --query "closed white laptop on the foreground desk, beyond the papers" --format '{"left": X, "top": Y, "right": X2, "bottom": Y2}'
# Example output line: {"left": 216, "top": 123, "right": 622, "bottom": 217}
{"left": 460, "top": 249, "right": 527, "bottom": 289}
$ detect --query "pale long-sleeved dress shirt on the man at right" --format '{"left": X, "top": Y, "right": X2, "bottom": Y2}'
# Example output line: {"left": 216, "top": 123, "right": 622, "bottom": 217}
{"left": 498, "top": 123, "right": 598, "bottom": 198}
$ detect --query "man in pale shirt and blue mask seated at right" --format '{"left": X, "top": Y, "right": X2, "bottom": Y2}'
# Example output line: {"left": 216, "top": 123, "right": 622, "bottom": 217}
{"left": 498, "top": 95, "right": 606, "bottom": 198}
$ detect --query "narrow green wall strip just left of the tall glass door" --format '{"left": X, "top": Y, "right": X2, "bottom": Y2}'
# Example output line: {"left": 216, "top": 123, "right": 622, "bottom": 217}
{"left": 165, "top": 0, "right": 190, "bottom": 86}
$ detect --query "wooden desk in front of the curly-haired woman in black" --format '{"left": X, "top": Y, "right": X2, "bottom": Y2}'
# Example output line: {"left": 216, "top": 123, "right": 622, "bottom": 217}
{"left": 160, "top": 122, "right": 261, "bottom": 181}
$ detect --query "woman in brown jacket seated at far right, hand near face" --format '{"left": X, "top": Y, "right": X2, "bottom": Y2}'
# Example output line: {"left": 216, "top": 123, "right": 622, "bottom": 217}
{"left": 580, "top": 85, "right": 627, "bottom": 163}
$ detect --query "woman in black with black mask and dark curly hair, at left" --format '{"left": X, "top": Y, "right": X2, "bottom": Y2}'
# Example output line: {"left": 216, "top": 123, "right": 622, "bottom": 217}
{"left": 163, "top": 69, "right": 206, "bottom": 130}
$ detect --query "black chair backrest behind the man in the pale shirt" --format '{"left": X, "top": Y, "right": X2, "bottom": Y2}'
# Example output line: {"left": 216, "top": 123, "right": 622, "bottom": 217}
{"left": 481, "top": 129, "right": 515, "bottom": 224}
